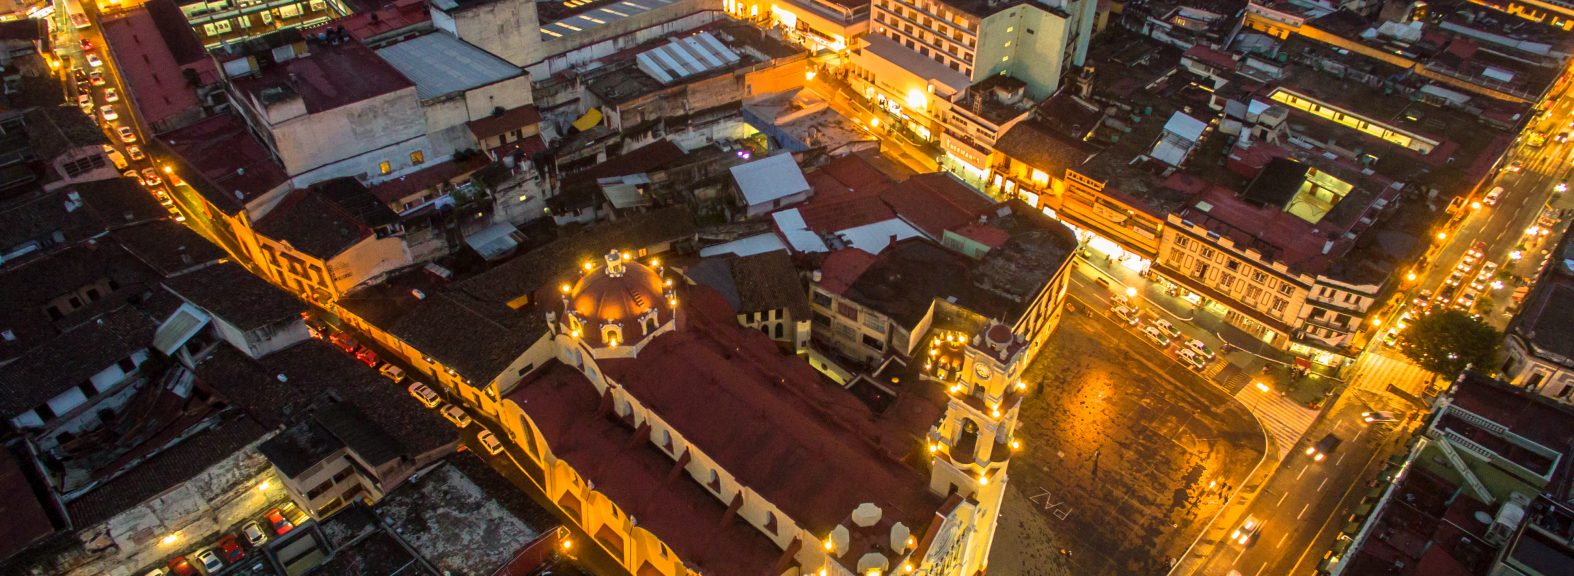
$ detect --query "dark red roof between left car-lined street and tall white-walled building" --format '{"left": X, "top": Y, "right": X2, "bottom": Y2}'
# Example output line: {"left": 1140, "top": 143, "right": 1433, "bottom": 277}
{"left": 161, "top": 112, "right": 290, "bottom": 214}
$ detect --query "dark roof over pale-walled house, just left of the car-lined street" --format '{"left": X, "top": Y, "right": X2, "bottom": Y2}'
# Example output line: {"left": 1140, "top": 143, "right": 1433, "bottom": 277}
{"left": 164, "top": 263, "right": 305, "bottom": 330}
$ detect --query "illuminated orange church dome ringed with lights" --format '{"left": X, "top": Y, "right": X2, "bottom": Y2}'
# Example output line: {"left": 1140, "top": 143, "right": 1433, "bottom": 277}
{"left": 565, "top": 252, "right": 672, "bottom": 346}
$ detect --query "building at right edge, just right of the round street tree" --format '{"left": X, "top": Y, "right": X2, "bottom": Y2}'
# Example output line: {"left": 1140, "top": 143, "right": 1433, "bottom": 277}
{"left": 1503, "top": 223, "right": 1574, "bottom": 403}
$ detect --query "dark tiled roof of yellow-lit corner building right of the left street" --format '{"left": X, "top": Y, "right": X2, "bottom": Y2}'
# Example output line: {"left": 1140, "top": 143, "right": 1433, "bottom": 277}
{"left": 255, "top": 178, "right": 398, "bottom": 260}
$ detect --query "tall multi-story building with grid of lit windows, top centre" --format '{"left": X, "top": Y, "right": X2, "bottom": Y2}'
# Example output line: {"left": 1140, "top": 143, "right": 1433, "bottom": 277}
{"left": 850, "top": 0, "right": 1096, "bottom": 140}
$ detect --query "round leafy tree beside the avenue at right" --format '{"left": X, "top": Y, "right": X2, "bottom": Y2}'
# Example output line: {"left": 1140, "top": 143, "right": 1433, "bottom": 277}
{"left": 1399, "top": 310, "right": 1503, "bottom": 378}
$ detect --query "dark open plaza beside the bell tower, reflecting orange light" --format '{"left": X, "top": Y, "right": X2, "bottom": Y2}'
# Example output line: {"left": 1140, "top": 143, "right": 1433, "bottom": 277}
{"left": 990, "top": 305, "right": 1264, "bottom": 574}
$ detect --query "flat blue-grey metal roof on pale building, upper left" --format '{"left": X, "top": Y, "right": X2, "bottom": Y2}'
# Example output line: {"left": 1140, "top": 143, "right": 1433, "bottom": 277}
{"left": 378, "top": 31, "right": 524, "bottom": 101}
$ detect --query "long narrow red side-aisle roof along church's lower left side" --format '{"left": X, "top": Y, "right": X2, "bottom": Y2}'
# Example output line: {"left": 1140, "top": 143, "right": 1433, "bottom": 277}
{"left": 508, "top": 360, "right": 781, "bottom": 574}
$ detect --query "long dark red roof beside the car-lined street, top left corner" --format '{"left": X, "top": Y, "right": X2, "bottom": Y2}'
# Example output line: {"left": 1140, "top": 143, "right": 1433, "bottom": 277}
{"left": 104, "top": 5, "right": 217, "bottom": 124}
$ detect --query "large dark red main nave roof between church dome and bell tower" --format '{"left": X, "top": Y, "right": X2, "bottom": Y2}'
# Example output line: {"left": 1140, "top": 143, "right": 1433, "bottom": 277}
{"left": 600, "top": 286, "right": 940, "bottom": 534}
